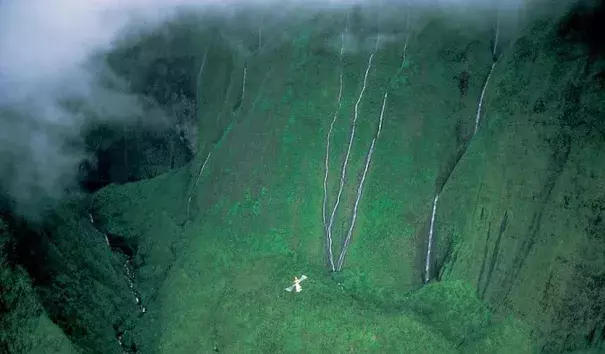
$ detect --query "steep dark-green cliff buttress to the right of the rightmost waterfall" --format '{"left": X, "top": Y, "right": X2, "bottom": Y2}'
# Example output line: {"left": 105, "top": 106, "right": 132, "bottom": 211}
{"left": 437, "top": 2, "right": 605, "bottom": 352}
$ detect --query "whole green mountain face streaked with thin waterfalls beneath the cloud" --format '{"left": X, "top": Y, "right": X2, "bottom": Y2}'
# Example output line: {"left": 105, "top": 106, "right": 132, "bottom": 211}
{"left": 3, "top": 0, "right": 605, "bottom": 353}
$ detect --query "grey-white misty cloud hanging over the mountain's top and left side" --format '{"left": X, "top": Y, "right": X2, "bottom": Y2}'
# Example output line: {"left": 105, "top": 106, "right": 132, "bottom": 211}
{"left": 0, "top": 0, "right": 528, "bottom": 217}
